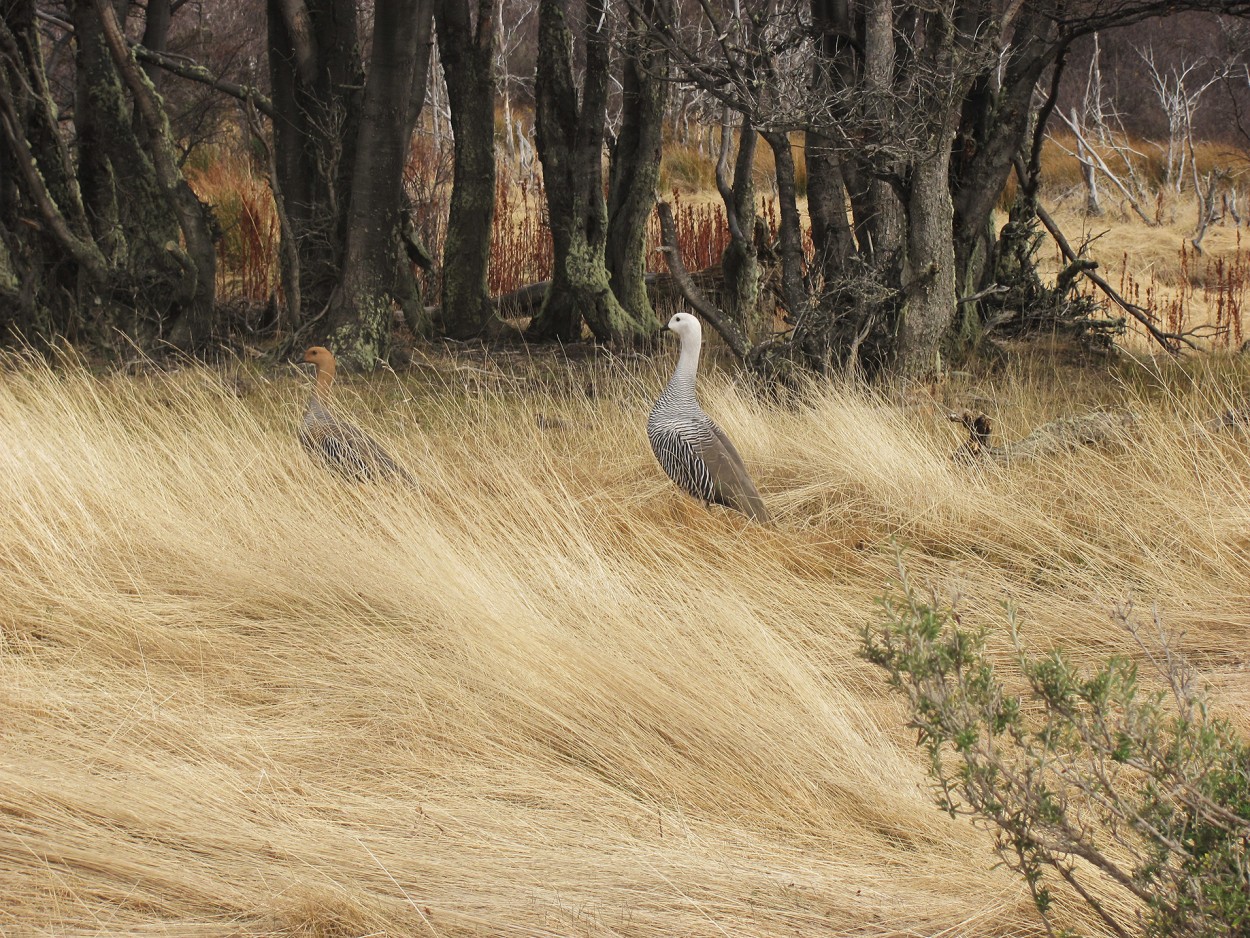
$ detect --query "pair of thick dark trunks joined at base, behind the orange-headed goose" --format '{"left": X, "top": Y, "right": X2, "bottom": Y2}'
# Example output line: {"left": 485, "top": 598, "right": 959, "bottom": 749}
{"left": 269, "top": 0, "right": 433, "bottom": 368}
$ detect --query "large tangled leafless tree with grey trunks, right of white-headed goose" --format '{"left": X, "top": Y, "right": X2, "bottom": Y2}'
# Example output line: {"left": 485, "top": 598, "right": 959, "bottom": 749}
{"left": 656, "top": 0, "right": 1250, "bottom": 374}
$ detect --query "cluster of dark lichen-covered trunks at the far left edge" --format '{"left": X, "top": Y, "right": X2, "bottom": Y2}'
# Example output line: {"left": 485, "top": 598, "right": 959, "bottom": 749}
{"left": 0, "top": 0, "right": 216, "bottom": 351}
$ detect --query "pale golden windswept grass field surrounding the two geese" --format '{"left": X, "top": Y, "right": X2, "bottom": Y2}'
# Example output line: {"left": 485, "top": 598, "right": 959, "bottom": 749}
{"left": 0, "top": 355, "right": 1250, "bottom": 938}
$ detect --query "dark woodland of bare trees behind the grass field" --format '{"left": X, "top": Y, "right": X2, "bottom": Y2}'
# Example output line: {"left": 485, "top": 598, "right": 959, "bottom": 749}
{"left": 7, "top": 0, "right": 1250, "bottom": 376}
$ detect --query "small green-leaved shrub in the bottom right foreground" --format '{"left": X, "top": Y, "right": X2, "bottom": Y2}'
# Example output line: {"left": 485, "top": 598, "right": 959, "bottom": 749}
{"left": 863, "top": 564, "right": 1250, "bottom": 938}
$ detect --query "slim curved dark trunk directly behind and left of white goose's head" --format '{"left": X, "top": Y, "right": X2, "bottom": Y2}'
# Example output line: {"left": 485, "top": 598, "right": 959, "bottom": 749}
{"left": 605, "top": 0, "right": 670, "bottom": 331}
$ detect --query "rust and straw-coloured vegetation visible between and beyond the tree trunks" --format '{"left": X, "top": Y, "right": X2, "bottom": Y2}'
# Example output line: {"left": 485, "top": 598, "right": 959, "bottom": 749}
{"left": 189, "top": 135, "right": 1250, "bottom": 348}
